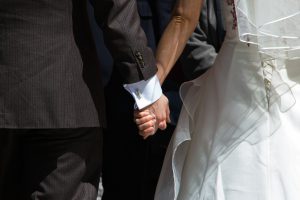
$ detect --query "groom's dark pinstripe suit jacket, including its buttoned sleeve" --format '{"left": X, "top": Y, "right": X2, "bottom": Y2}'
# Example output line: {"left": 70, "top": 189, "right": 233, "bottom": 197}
{"left": 0, "top": 0, "right": 156, "bottom": 128}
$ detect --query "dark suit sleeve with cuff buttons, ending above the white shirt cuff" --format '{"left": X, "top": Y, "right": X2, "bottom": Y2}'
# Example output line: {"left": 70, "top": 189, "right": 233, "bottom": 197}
{"left": 93, "top": 0, "right": 157, "bottom": 84}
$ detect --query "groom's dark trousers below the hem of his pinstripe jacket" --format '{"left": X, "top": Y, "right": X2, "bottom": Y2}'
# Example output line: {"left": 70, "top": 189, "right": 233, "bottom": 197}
{"left": 0, "top": 128, "right": 102, "bottom": 200}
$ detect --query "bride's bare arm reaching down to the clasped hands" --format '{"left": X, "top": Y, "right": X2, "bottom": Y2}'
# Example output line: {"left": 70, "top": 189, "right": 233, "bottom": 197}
{"left": 156, "top": 0, "right": 203, "bottom": 83}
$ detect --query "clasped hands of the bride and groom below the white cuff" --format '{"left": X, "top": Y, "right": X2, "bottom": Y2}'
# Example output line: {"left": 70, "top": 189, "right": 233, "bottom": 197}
{"left": 134, "top": 95, "right": 170, "bottom": 139}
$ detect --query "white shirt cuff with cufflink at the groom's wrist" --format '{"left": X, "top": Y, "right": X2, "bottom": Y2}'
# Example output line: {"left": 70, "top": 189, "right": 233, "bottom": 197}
{"left": 124, "top": 75, "right": 162, "bottom": 109}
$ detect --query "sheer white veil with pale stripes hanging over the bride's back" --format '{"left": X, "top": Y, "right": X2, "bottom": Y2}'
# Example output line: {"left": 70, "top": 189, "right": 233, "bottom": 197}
{"left": 235, "top": 0, "right": 300, "bottom": 59}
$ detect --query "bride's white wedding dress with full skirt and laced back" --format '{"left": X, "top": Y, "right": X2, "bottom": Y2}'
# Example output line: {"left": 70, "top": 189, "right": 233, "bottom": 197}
{"left": 155, "top": 0, "right": 300, "bottom": 200}
